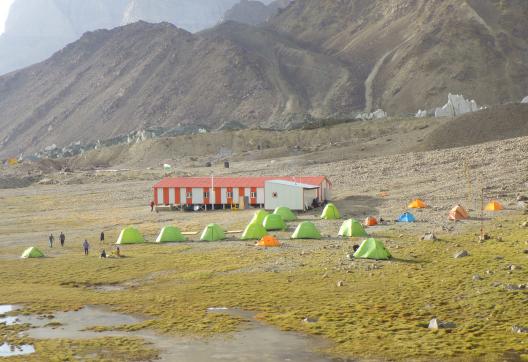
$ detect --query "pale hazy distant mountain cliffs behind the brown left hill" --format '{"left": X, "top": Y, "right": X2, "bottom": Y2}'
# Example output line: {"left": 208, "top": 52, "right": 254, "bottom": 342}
{"left": 0, "top": 0, "right": 243, "bottom": 74}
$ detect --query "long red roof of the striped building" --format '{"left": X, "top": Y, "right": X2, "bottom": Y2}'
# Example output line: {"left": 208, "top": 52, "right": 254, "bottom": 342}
{"left": 154, "top": 176, "right": 331, "bottom": 188}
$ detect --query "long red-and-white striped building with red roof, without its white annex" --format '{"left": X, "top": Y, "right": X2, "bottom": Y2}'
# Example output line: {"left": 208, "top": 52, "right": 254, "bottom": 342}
{"left": 153, "top": 176, "right": 332, "bottom": 208}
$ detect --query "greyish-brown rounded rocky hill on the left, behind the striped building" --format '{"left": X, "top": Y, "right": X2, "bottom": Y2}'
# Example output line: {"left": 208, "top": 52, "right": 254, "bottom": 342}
{"left": 0, "top": 22, "right": 354, "bottom": 157}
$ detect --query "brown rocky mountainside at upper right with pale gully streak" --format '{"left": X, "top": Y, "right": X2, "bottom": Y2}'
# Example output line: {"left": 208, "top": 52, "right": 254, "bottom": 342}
{"left": 273, "top": 0, "right": 528, "bottom": 114}
